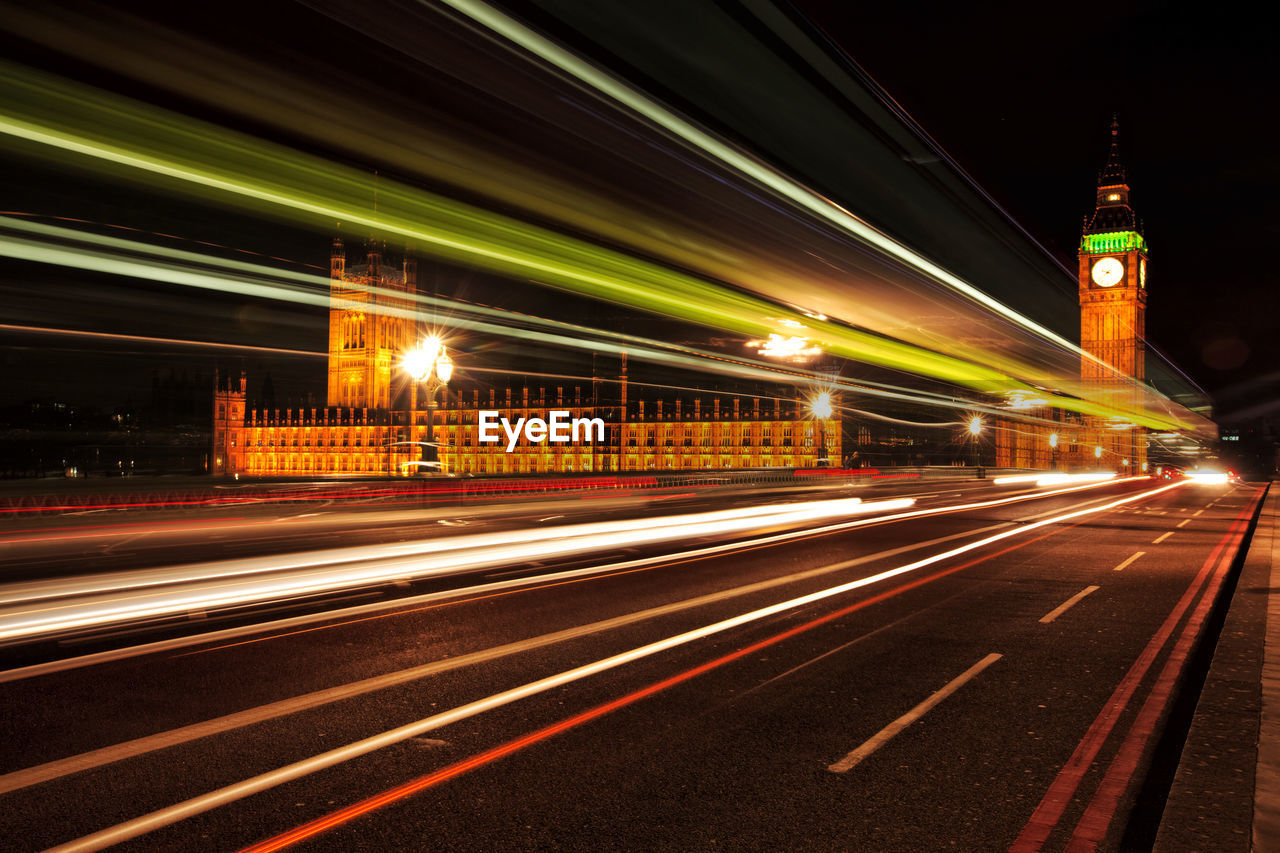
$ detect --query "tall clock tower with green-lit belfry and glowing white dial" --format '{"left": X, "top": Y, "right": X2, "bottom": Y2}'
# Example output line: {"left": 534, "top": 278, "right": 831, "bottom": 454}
{"left": 1079, "top": 118, "right": 1147, "bottom": 475}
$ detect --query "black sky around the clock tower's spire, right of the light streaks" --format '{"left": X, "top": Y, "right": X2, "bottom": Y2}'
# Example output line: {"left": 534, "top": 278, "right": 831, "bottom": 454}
{"left": 795, "top": 0, "right": 1280, "bottom": 415}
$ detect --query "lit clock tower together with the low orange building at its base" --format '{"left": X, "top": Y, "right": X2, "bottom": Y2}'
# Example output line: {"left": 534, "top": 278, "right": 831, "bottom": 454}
{"left": 996, "top": 119, "right": 1147, "bottom": 473}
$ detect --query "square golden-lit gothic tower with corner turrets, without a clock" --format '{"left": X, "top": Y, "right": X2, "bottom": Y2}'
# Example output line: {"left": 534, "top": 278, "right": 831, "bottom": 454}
{"left": 328, "top": 240, "right": 417, "bottom": 410}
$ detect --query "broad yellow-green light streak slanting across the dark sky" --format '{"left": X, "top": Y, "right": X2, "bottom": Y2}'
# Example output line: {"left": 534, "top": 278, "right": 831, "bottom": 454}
{"left": 0, "top": 65, "right": 1184, "bottom": 429}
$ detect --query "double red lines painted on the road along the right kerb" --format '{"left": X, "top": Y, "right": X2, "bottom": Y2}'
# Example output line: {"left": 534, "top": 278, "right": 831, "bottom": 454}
{"left": 1009, "top": 492, "right": 1261, "bottom": 853}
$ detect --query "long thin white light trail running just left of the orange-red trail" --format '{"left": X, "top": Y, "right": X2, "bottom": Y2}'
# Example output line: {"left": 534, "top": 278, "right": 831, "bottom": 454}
{"left": 51, "top": 483, "right": 1184, "bottom": 853}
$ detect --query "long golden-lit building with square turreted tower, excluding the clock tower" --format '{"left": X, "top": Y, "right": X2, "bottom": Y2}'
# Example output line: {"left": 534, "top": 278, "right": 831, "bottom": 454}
{"left": 212, "top": 241, "right": 841, "bottom": 476}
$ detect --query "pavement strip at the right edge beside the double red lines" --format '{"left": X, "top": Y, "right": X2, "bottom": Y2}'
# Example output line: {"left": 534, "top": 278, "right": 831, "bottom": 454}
{"left": 1155, "top": 483, "right": 1280, "bottom": 853}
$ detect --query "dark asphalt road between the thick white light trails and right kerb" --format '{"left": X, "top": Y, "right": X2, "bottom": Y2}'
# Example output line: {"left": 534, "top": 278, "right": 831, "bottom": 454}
{"left": 0, "top": 480, "right": 1261, "bottom": 850}
